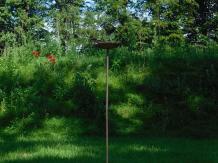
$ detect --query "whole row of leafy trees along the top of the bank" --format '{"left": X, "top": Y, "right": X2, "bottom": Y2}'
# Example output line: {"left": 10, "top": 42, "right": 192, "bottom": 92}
{"left": 0, "top": 0, "right": 218, "bottom": 53}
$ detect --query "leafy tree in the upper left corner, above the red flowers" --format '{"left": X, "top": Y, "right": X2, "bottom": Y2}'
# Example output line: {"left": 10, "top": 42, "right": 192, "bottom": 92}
{"left": 0, "top": 0, "right": 44, "bottom": 44}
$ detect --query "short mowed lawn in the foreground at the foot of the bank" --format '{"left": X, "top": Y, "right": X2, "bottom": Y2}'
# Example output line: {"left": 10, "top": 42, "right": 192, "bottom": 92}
{"left": 0, "top": 118, "right": 218, "bottom": 163}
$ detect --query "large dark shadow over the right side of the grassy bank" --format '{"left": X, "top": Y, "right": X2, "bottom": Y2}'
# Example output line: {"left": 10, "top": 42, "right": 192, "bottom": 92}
{"left": 119, "top": 54, "right": 218, "bottom": 138}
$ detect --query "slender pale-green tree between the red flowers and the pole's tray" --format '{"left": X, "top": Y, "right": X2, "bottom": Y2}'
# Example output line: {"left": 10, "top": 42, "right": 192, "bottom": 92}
{"left": 52, "top": 0, "right": 84, "bottom": 53}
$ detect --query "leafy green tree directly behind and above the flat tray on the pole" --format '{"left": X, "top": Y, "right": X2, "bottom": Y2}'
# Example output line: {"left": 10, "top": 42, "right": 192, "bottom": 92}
{"left": 93, "top": 0, "right": 150, "bottom": 50}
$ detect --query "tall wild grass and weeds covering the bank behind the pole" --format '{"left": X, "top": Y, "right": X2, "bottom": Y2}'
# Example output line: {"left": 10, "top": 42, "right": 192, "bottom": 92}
{"left": 0, "top": 44, "right": 218, "bottom": 137}
